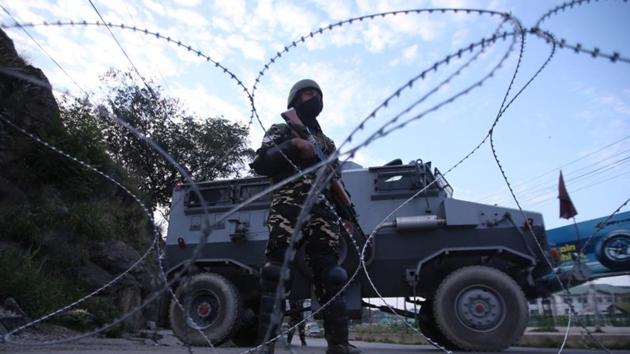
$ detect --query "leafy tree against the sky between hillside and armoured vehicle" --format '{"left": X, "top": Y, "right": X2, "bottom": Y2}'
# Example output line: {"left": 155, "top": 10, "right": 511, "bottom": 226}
{"left": 62, "top": 72, "right": 254, "bottom": 211}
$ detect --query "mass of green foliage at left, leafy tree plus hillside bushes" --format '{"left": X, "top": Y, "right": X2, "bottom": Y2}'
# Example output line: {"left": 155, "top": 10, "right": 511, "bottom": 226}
{"left": 0, "top": 68, "right": 253, "bottom": 336}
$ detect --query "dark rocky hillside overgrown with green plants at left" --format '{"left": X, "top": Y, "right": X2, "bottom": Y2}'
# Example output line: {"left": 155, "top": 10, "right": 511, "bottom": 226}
{"left": 0, "top": 30, "right": 159, "bottom": 331}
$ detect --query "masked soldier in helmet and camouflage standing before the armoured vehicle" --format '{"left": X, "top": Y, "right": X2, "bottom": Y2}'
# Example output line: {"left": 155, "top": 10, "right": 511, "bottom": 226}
{"left": 251, "top": 79, "right": 360, "bottom": 354}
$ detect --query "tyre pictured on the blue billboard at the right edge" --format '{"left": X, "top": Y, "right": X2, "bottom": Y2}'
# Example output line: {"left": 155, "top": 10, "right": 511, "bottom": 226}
{"left": 595, "top": 230, "right": 630, "bottom": 270}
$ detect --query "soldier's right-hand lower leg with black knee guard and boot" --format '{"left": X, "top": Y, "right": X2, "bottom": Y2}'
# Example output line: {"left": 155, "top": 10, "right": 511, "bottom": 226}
{"left": 312, "top": 257, "right": 361, "bottom": 354}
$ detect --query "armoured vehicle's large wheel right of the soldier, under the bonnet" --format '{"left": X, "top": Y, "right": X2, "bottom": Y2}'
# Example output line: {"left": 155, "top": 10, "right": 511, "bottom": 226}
{"left": 433, "top": 266, "right": 529, "bottom": 351}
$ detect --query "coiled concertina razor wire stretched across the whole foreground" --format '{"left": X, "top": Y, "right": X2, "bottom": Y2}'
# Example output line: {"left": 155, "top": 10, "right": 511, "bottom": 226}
{"left": 0, "top": 0, "right": 630, "bottom": 352}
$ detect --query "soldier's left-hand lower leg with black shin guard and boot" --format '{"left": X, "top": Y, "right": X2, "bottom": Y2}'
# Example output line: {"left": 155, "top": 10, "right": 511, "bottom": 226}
{"left": 256, "top": 261, "right": 282, "bottom": 354}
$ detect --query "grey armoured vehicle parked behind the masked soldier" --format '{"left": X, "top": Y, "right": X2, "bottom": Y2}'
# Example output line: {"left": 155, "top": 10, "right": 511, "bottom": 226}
{"left": 165, "top": 160, "right": 572, "bottom": 351}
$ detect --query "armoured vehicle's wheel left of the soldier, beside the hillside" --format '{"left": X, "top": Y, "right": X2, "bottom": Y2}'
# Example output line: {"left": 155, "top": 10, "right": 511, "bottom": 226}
{"left": 169, "top": 273, "right": 241, "bottom": 346}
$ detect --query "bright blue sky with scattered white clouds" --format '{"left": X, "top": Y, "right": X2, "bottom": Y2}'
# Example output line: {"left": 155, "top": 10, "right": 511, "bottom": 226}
{"left": 0, "top": 0, "right": 630, "bottom": 285}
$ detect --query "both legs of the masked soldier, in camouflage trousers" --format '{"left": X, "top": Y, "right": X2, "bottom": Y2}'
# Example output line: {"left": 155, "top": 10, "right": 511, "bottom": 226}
{"left": 258, "top": 181, "right": 348, "bottom": 344}
